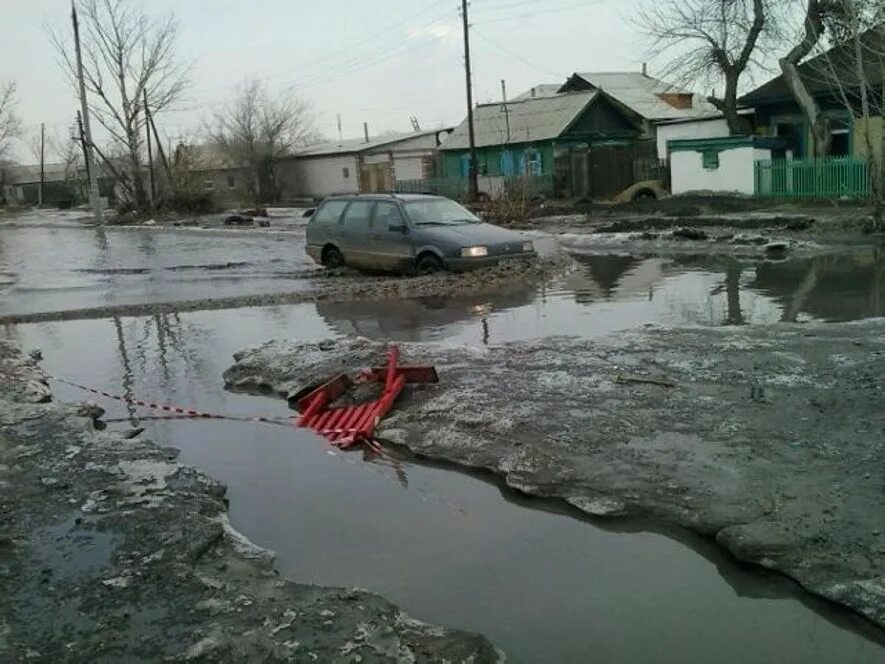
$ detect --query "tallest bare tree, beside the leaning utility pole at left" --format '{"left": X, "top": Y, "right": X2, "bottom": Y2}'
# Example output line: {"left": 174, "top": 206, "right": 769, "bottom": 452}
{"left": 49, "top": 0, "right": 188, "bottom": 209}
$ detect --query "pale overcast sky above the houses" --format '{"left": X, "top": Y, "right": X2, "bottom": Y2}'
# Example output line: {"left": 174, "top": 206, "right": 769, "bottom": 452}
{"left": 0, "top": 0, "right": 654, "bottom": 159}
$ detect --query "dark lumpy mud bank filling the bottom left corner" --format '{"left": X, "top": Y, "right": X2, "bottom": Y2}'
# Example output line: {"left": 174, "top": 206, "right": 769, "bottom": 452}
{"left": 0, "top": 341, "right": 500, "bottom": 662}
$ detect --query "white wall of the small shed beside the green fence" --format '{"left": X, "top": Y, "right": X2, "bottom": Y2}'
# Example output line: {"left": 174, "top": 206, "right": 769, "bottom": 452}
{"left": 670, "top": 145, "right": 767, "bottom": 195}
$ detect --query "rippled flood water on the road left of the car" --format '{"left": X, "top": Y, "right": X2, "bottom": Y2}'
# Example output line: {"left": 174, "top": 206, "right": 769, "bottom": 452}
{"left": 0, "top": 227, "right": 317, "bottom": 315}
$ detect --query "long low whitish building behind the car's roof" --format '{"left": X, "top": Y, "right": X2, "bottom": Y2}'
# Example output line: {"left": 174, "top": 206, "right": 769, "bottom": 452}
{"left": 277, "top": 128, "right": 452, "bottom": 198}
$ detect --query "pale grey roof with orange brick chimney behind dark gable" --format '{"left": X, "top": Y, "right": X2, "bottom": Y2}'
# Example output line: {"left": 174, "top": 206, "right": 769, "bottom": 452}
{"left": 561, "top": 72, "right": 716, "bottom": 120}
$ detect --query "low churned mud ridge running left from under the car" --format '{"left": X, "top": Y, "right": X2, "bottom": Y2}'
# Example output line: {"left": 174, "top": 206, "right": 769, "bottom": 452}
{"left": 0, "top": 252, "right": 574, "bottom": 325}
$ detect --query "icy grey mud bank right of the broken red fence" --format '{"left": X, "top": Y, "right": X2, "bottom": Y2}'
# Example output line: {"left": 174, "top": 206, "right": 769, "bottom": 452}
{"left": 225, "top": 320, "right": 885, "bottom": 627}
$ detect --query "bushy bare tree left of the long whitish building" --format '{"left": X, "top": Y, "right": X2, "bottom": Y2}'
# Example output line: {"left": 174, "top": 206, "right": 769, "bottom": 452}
{"left": 209, "top": 80, "right": 316, "bottom": 203}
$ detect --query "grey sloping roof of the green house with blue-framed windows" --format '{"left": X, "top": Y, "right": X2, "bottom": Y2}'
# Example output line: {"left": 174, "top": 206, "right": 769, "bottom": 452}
{"left": 440, "top": 92, "right": 597, "bottom": 150}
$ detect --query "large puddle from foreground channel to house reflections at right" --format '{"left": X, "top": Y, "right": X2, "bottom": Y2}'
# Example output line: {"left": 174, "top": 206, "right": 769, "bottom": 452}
{"left": 3, "top": 226, "right": 885, "bottom": 662}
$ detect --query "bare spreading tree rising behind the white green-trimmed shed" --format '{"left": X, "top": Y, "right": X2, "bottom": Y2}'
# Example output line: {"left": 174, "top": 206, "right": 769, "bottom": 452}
{"left": 636, "top": 0, "right": 777, "bottom": 134}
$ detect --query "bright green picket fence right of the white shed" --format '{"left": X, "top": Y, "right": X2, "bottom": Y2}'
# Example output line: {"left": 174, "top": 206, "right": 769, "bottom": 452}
{"left": 756, "top": 157, "right": 871, "bottom": 199}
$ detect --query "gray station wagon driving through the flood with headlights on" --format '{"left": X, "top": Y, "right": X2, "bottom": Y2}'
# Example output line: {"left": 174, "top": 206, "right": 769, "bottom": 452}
{"left": 307, "top": 194, "right": 536, "bottom": 274}
